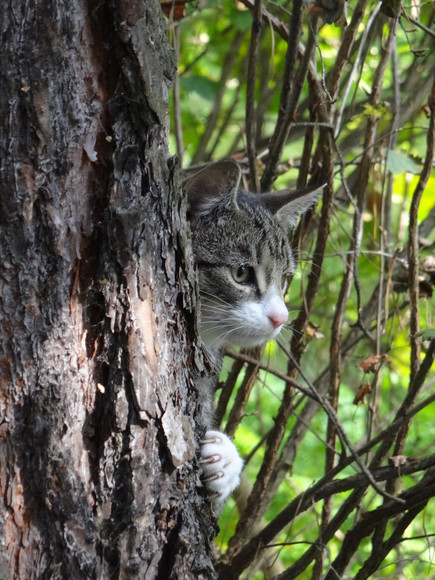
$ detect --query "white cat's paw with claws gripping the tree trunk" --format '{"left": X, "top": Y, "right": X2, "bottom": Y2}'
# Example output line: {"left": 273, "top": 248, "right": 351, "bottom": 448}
{"left": 201, "top": 431, "right": 243, "bottom": 507}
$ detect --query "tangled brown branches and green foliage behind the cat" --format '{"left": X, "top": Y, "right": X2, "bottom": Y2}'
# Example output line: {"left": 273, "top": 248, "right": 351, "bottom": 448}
{"left": 171, "top": 0, "right": 435, "bottom": 578}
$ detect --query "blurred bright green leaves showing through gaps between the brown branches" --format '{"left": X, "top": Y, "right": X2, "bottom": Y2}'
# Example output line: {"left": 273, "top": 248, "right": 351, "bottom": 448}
{"left": 170, "top": 0, "right": 435, "bottom": 579}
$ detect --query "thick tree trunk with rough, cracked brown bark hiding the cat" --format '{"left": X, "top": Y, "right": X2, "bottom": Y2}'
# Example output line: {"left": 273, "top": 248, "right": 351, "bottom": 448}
{"left": 0, "top": 0, "right": 218, "bottom": 579}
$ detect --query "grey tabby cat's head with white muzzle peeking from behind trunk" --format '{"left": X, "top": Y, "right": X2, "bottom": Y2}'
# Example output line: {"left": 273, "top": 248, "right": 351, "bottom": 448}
{"left": 185, "top": 160, "right": 320, "bottom": 351}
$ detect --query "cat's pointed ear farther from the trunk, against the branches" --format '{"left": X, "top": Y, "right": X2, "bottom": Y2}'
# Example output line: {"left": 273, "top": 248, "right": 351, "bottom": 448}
{"left": 260, "top": 183, "right": 326, "bottom": 229}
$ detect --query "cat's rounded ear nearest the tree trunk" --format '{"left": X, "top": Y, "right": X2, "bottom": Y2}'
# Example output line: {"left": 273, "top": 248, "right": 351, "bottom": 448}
{"left": 184, "top": 159, "right": 242, "bottom": 219}
